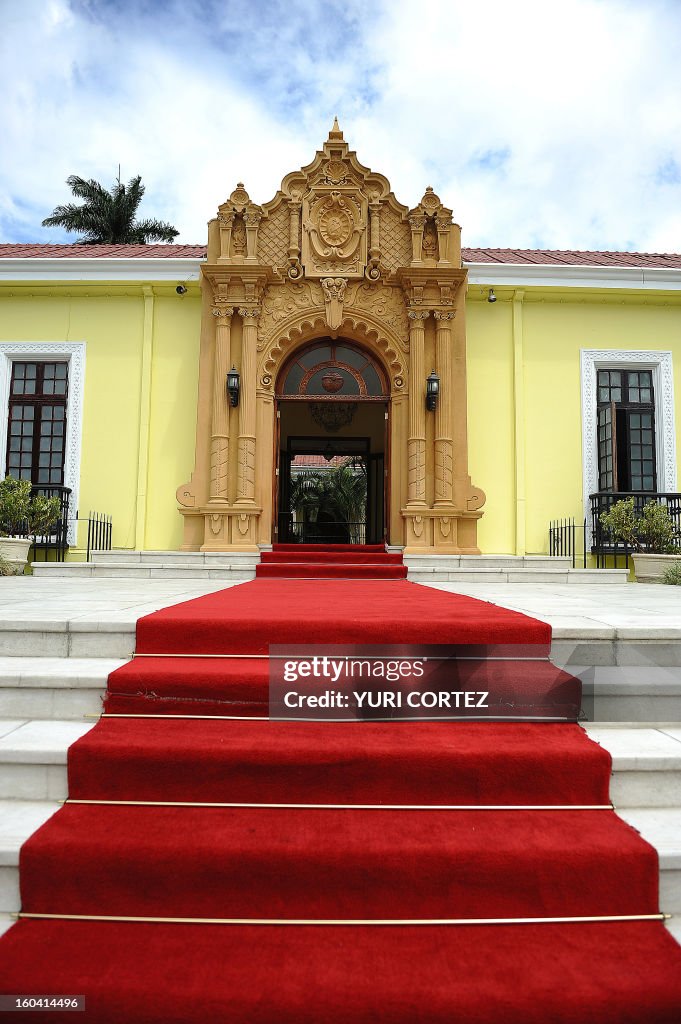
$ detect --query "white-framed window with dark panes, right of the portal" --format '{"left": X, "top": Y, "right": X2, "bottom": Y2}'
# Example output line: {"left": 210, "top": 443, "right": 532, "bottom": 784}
{"left": 581, "top": 348, "right": 677, "bottom": 521}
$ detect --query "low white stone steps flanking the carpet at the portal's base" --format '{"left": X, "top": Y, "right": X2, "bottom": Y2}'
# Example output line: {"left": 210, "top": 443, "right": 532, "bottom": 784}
{"left": 32, "top": 548, "right": 628, "bottom": 584}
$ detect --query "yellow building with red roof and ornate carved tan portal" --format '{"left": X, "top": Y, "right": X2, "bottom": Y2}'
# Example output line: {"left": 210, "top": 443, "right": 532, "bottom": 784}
{"left": 0, "top": 125, "right": 681, "bottom": 558}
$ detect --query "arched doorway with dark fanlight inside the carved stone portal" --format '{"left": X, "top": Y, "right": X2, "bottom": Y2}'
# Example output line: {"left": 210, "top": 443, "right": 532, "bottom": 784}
{"left": 273, "top": 338, "right": 389, "bottom": 544}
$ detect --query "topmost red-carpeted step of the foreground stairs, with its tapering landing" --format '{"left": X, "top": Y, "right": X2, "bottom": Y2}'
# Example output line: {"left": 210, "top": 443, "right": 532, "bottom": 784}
{"left": 136, "top": 580, "right": 551, "bottom": 654}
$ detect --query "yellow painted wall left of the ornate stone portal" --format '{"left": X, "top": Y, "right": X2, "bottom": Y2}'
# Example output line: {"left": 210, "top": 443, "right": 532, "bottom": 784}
{"left": 0, "top": 284, "right": 200, "bottom": 557}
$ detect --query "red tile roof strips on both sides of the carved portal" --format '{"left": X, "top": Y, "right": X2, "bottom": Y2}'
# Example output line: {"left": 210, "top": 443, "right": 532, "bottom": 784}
{"left": 0, "top": 244, "right": 681, "bottom": 269}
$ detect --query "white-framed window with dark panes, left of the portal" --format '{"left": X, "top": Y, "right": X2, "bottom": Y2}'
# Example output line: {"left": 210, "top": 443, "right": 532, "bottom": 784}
{"left": 0, "top": 342, "right": 85, "bottom": 545}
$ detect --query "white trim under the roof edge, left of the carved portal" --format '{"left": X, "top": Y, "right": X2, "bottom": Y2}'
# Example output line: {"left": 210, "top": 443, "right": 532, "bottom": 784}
{"left": 0, "top": 256, "right": 204, "bottom": 284}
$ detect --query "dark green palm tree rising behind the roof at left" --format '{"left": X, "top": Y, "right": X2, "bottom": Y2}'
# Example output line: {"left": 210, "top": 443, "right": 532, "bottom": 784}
{"left": 43, "top": 174, "right": 179, "bottom": 246}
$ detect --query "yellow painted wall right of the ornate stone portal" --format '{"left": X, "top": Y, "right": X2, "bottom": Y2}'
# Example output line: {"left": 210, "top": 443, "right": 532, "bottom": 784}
{"left": 467, "top": 289, "right": 681, "bottom": 554}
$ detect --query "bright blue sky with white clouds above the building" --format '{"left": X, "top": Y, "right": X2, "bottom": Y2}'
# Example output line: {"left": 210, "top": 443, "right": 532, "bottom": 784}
{"left": 0, "top": 0, "right": 681, "bottom": 252}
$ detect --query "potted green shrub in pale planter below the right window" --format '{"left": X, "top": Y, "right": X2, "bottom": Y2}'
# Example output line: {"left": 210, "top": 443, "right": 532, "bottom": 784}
{"left": 600, "top": 498, "right": 681, "bottom": 583}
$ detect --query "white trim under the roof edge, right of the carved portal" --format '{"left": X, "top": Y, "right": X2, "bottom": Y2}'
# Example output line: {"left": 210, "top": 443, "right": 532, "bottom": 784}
{"left": 464, "top": 262, "right": 681, "bottom": 292}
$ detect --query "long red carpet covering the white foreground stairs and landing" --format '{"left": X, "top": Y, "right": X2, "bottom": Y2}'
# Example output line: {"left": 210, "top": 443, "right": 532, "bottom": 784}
{"left": 0, "top": 573, "right": 681, "bottom": 1024}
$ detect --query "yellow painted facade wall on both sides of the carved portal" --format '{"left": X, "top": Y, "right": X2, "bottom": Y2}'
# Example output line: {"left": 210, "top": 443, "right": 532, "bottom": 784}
{"left": 0, "top": 283, "right": 681, "bottom": 557}
